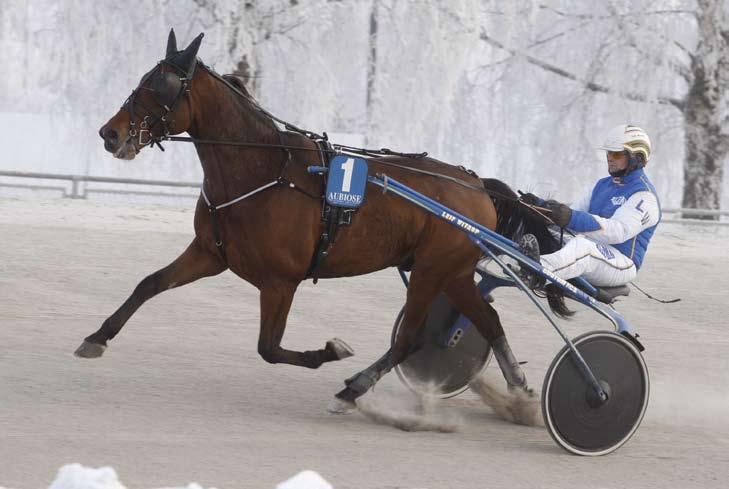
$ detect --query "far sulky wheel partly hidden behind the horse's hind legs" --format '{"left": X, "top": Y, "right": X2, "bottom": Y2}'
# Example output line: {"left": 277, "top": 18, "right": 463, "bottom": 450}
{"left": 391, "top": 293, "right": 491, "bottom": 399}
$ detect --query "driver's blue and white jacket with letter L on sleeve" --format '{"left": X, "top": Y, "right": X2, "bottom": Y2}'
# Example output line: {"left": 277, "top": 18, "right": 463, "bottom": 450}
{"left": 567, "top": 168, "right": 661, "bottom": 268}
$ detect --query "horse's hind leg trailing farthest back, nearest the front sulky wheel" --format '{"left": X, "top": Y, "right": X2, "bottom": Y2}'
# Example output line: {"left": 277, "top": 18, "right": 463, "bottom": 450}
{"left": 445, "top": 275, "right": 529, "bottom": 392}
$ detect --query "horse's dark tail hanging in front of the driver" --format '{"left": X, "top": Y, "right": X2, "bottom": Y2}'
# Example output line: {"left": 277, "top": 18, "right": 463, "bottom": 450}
{"left": 481, "top": 178, "right": 574, "bottom": 318}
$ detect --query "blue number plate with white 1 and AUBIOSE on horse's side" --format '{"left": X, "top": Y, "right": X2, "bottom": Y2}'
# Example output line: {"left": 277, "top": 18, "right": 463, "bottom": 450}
{"left": 327, "top": 155, "right": 367, "bottom": 208}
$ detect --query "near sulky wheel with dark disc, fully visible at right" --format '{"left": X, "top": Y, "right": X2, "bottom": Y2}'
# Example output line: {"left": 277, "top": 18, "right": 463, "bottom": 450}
{"left": 542, "top": 331, "right": 649, "bottom": 455}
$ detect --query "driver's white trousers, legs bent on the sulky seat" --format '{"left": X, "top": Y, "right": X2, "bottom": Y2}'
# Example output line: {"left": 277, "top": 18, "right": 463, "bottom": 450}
{"left": 541, "top": 235, "right": 638, "bottom": 287}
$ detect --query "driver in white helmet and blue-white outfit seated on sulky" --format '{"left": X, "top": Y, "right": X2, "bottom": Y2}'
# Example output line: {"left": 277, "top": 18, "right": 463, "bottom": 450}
{"left": 519, "top": 124, "right": 661, "bottom": 287}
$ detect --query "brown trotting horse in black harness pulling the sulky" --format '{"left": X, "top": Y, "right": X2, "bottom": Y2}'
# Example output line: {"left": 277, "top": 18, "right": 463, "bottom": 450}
{"left": 76, "top": 31, "right": 527, "bottom": 408}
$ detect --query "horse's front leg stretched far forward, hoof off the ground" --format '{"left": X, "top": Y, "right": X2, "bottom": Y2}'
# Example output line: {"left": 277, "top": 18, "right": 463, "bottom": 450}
{"left": 75, "top": 238, "right": 227, "bottom": 358}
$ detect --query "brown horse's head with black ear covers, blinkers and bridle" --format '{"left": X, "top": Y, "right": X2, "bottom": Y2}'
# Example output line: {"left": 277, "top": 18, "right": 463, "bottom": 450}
{"left": 99, "top": 30, "right": 203, "bottom": 160}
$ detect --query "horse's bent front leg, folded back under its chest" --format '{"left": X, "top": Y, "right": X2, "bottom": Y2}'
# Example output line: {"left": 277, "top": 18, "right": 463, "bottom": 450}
{"left": 258, "top": 283, "right": 354, "bottom": 368}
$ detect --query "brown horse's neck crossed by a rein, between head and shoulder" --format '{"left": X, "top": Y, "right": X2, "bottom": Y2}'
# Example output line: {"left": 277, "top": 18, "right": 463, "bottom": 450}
{"left": 188, "top": 72, "right": 282, "bottom": 204}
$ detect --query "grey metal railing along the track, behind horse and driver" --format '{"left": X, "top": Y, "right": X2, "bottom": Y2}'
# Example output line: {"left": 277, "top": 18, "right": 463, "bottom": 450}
{"left": 0, "top": 170, "right": 729, "bottom": 226}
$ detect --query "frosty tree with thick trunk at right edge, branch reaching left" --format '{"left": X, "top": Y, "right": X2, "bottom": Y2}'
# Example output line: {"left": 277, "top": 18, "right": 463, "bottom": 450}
{"left": 480, "top": 0, "right": 729, "bottom": 209}
